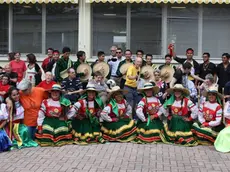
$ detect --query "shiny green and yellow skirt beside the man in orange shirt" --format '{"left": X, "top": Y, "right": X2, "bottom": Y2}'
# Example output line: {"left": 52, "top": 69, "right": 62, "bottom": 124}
{"left": 12, "top": 123, "right": 38, "bottom": 149}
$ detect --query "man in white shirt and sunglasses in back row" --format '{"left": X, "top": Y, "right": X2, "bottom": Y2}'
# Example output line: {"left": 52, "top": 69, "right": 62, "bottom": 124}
{"left": 108, "top": 48, "right": 124, "bottom": 86}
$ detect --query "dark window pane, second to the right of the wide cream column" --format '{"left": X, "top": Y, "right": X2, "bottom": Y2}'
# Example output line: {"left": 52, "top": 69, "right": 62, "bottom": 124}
{"left": 131, "top": 3, "right": 162, "bottom": 55}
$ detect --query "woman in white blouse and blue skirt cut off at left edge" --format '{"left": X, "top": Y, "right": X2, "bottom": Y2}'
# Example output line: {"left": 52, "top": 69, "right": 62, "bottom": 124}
{"left": 0, "top": 103, "right": 12, "bottom": 152}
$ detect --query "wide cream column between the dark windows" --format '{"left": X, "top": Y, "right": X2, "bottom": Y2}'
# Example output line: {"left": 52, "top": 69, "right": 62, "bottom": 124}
{"left": 78, "top": 0, "right": 92, "bottom": 58}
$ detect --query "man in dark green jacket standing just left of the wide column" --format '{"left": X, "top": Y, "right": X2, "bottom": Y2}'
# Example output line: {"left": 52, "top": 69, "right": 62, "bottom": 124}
{"left": 55, "top": 47, "right": 73, "bottom": 82}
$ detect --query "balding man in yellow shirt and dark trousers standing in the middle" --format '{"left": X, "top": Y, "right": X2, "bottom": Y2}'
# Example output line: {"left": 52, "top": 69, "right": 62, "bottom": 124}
{"left": 124, "top": 57, "right": 142, "bottom": 115}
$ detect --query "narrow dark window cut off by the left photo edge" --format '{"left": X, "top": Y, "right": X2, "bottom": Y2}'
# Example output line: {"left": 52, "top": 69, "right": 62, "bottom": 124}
{"left": 0, "top": 4, "right": 9, "bottom": 54}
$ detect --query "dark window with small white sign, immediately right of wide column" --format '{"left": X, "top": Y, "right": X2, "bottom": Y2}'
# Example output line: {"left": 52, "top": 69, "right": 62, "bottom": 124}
{"left": 92, "top": 3, "right": 127, "bottom": 55}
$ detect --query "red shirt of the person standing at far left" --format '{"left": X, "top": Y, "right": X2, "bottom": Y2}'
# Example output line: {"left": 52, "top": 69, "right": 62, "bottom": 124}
{"left": 10, "top": 60, "right": 26, "bottom": 82}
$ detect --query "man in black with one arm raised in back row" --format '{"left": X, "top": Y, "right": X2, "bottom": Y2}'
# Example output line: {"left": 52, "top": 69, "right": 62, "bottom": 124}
{"left": 173, "top": 48, "right": 200, "bottom": 81}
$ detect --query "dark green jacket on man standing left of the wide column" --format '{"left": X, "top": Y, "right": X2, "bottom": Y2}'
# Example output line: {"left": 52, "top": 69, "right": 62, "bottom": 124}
{"left": 55, "top": 57, "right": 73, "bottom": 82}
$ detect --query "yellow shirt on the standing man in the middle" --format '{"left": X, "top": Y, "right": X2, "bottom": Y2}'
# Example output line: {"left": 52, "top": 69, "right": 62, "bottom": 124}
{"left": 125, "top": 65, "right": 140, "bottom": 88}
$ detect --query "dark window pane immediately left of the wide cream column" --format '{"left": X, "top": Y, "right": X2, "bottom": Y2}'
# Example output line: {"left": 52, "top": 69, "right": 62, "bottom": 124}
{"left": 46, "top": 3, "right": 78, "bottom": 53}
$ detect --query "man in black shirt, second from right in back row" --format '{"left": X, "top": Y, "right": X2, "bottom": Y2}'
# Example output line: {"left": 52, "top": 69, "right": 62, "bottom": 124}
{"left": 199, "top": 52, "right": 216, "bottom": 82}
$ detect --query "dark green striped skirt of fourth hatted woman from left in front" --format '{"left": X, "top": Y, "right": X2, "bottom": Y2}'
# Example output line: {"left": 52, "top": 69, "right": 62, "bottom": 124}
{"left": 134, "top": 118, "right": 164, "bottom": 143}
